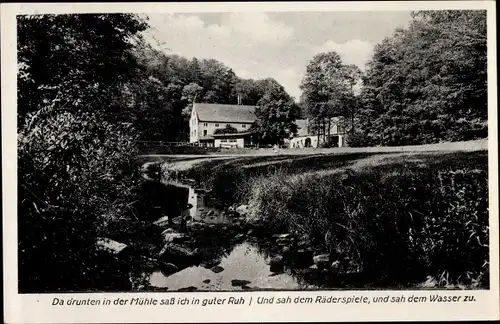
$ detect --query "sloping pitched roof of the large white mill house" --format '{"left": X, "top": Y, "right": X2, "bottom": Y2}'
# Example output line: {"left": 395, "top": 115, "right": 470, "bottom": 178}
{"left": 194, "top": 103, "right": 256, "bottom": 123}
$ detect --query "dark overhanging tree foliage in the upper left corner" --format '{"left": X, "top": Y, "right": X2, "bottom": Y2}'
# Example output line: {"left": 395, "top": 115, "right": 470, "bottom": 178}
{"left": 17, "top": 14, "right": 147, "bottom": 125}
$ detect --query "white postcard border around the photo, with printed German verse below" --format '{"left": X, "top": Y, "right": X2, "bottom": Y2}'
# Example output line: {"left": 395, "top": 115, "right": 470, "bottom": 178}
{"left": 1, "top": 1, "right": 500, "bottom": 323}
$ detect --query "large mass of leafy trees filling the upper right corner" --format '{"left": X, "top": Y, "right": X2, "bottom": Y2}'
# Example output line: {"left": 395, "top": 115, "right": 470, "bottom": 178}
{"left": 359, "top": 10, "right": 487, "bottom": 145}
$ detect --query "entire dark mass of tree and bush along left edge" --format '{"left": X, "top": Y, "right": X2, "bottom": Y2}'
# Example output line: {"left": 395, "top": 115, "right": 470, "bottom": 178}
{"left": 18, "top": 14, "right": 146, "bottom": 292}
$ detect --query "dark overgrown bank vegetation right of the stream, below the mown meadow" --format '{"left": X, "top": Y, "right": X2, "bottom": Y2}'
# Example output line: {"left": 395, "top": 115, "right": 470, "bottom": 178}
{"left": 246, "top": 164, "right": 488, "bottom": 286}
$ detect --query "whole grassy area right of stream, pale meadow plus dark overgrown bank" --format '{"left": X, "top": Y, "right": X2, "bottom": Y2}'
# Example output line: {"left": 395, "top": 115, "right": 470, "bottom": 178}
{"left": 162, "top": 151, "right": 489, "bottom": 288}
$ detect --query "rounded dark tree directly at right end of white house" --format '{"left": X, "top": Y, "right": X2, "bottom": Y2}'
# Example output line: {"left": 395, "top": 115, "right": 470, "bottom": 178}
{"left": 251, "top": 79, "right": 297, "bottom": 144}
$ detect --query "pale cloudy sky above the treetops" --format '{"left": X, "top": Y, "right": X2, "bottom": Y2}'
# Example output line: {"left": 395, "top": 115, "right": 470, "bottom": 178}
{"left": 145, "top": 11, "right": 411, "bottom": 100}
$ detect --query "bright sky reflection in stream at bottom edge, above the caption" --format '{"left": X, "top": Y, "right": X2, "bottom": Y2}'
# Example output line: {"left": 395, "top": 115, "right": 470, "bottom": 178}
{"left": 149, "top": 242, "right": 312, "bottom": 290}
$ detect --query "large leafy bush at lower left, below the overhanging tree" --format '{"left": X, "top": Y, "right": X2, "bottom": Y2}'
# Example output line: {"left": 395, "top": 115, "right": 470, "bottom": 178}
{"left": 18, "top": 106, "right": 137, "bottom": 292}
